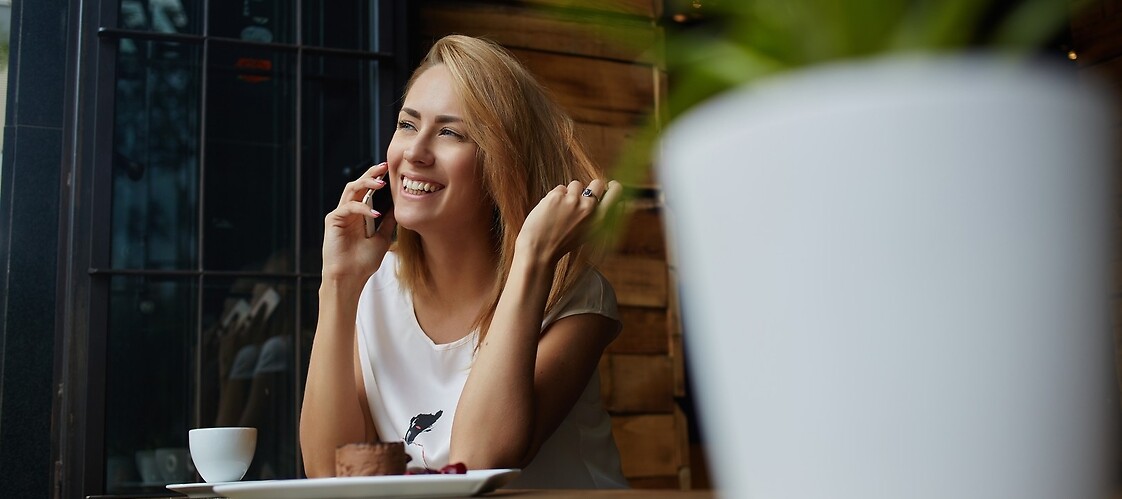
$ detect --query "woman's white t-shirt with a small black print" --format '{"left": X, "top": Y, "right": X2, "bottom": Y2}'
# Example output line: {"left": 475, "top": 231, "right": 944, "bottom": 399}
{"left": 356, "top": 252, "right": 627, "bottom": 488}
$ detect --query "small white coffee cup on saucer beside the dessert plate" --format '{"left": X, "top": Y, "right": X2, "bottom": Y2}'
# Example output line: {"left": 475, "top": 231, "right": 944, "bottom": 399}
{"left": 188, "top": 427, "right": 257, "bottom": 483}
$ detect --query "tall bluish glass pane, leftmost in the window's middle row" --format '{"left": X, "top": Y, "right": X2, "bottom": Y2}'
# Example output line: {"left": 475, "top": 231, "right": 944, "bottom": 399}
{"left": 110, "top": 38, "right": 201, "bottom": 269}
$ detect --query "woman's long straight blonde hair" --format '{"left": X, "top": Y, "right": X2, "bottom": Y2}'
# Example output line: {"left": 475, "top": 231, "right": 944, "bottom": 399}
{"left": 396, "top": 35, "right": 601, "bottom": 344}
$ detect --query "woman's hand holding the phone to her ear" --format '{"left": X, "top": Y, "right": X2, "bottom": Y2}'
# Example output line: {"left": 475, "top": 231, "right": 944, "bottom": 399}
{"left": 323, "top": 163, "right": 397, "bottom": 283}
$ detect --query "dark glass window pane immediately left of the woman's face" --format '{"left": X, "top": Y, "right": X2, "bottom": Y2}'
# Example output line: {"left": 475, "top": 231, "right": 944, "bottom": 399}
{"left": 301, "top": 56, "right": 385, "bottom": 274}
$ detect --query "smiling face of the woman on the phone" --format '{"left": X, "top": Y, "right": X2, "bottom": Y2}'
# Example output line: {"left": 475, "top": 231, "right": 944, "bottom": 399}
{"left": 386, "top": 65, "right": 493, "bottom": 235}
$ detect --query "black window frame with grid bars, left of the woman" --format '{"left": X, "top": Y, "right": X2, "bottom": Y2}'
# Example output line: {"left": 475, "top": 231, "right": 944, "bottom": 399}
{"left": 47, "top": 0, "right": 419, "bottom": 497}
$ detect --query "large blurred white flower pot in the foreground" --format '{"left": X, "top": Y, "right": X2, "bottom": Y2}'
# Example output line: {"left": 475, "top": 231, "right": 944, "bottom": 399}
{"left": 659, "top": 57, "right": 1118, "bottom": 499}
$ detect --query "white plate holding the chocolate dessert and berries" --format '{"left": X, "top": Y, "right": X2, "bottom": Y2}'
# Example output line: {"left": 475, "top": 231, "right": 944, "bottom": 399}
{"left": 214, "top": 470, "right": 521, "bottom": 499}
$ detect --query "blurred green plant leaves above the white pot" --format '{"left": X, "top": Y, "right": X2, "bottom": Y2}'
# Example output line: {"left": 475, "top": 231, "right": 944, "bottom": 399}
{"left": 614, "top": 0, "right": 1078, "bottom": 185}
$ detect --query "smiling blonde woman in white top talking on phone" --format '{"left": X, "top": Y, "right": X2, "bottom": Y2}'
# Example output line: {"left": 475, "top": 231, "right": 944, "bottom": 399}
{"left": 301, "top": 36, "right": 626, "bottom": 488}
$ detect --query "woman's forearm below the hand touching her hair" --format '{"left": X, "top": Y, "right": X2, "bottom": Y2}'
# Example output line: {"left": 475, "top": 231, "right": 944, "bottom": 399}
{"left": 450, "top": 251, "right": 554, "bottom": 469}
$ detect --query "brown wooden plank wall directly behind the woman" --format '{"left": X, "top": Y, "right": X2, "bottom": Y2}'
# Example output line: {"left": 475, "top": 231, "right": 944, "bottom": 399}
{"left": 420, "top": 0, "right": 690, "bottom": 488}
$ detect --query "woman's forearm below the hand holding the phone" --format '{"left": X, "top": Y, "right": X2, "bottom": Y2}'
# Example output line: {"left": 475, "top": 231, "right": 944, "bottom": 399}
{"left": 300, "top": 279, "right": 367, "bottom": 477}
